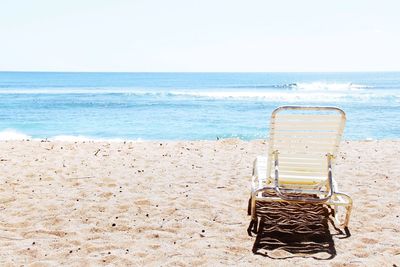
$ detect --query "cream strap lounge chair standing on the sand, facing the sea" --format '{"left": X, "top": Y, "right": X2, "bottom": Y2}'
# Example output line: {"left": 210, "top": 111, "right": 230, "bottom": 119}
{"left": 248, "top": 106, "right": 352, "bottom": 234}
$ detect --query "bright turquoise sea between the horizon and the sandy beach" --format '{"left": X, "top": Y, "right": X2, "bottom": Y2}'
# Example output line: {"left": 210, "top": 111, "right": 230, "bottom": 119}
{"left": 0, "top": 72, "right": 400, "bottom": 140}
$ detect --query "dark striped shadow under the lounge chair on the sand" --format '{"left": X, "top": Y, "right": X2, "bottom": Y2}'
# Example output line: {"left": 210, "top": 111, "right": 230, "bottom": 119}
{"left": 249, "top": 202, "right": 349, "bottom": 260}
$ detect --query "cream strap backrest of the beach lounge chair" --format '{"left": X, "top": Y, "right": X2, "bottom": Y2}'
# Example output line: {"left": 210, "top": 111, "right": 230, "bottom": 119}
{"left": 267, "top": 106, "right": 346, "bottom": 182}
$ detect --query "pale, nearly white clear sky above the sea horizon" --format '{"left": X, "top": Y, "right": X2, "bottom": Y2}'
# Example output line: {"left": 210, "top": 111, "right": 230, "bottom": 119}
{"left": 0, "top": 0, "right": 400, "bottom": 72}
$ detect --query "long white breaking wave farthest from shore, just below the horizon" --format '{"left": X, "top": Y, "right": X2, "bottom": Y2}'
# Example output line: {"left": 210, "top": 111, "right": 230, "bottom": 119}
{"left": 0, "top": 82, "right": 400, "bottom": 103}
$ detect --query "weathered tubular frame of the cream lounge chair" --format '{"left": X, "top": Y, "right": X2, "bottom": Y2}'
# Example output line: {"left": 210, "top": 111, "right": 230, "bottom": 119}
{"left": 249, "top": 106, "right": 353, "bottom": 232}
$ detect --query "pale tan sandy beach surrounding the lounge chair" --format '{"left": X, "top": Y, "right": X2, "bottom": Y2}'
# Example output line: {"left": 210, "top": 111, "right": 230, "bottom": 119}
{"left": 0, "top": 139, "right": 400, "bottom": 266}
